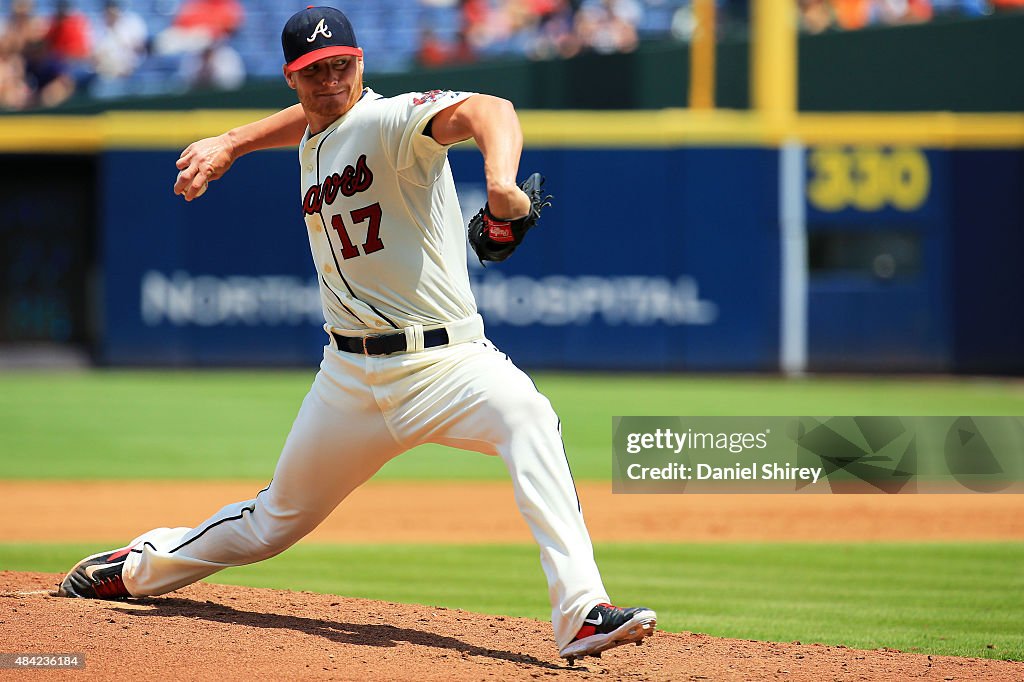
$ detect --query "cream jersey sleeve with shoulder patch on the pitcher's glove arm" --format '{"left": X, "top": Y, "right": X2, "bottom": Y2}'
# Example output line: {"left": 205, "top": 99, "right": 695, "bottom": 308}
{"left": 381, "top": 90, "right": 476, "bottom": 173}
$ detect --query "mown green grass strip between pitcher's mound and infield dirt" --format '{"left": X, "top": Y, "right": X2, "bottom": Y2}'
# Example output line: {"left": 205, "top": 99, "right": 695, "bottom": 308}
{"left": 6, "top": 543, "right": 1024, "bottom": 660}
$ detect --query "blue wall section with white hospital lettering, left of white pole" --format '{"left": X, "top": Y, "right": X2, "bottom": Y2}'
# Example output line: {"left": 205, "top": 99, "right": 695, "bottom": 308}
{"left": 100, "top": 142, "right": 779, "bottom": 370}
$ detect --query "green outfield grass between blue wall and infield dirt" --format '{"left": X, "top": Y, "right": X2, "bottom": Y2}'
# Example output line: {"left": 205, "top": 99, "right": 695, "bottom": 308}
{"left": 0, "top": 371, "right": 1024, "bottom": 480}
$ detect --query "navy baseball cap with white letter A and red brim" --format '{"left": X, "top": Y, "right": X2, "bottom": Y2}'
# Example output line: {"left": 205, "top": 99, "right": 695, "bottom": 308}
{"left": 281, "top": 6, "right": 362, "bottom": 71}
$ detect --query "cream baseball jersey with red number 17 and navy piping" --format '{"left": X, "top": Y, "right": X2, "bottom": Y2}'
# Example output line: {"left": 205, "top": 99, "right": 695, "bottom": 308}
{"left": 299, "top": 88, "right": 476, "bottom": 331}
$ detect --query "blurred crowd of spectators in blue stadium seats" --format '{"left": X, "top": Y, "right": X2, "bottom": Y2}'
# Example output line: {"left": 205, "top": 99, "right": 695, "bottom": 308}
{"left": 0, "top": 0, "right": 1024, "bottom": 110}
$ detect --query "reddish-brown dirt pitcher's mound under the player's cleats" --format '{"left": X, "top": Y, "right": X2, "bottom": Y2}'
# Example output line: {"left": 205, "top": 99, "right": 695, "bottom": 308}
{"left": 0, "top": 571, "right": 1024, "bottom": 682}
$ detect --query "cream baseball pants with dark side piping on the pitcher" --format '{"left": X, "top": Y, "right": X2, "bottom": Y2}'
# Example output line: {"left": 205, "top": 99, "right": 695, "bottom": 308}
{"left": 123, "top": 329, "right": 609, "bottom": 648}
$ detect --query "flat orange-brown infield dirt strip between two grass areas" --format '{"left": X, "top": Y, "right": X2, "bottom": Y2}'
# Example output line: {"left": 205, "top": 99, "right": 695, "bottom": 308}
{"left": 0, "top": 481, "right": 1024, "bottom": 543}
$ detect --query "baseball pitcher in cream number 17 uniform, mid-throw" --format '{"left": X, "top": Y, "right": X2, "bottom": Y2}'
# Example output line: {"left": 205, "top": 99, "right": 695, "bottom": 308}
{"left": 58, "top": 7, "right": 656, "bottom": 664}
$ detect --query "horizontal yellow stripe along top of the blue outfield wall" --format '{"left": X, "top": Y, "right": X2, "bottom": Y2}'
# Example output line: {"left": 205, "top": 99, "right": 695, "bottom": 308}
{"left": 0, "top": 110, "right": 1024, "bottom": 153}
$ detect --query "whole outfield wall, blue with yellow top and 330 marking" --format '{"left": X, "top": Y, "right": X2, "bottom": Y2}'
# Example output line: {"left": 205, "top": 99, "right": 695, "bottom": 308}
{"left": 0, "top": 111, "right": 1024, "bottom": 373}
